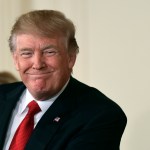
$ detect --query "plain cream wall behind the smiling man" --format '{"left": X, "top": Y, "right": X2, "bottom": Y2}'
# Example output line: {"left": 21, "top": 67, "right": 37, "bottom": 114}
{"left": 0, "top": 0, "right": 150, "bottom": 150}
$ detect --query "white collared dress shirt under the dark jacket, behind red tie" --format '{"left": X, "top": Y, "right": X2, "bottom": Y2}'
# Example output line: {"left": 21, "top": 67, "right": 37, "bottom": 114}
{"left": 3, "top": 81, "right": 69, "bottom": 150}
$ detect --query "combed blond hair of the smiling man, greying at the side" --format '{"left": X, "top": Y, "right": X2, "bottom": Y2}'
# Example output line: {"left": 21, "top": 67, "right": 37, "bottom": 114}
{"left": 9, "top": 10, "right": 79, "bottom": 53}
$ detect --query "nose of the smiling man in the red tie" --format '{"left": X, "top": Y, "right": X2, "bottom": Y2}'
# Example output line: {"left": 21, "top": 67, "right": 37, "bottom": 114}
{"left": 32, "top": 53, "right": 46, "bottom": 70}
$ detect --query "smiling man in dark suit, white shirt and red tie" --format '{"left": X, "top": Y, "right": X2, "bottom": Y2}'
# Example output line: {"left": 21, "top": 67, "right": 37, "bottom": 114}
{"left": 0, "top": 10, "right": 126, "bottom": 150}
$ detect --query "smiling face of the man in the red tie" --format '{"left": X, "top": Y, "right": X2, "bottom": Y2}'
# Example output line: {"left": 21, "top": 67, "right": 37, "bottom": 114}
{"left": 13, "top": 34, "right": 76, "bottom": 100}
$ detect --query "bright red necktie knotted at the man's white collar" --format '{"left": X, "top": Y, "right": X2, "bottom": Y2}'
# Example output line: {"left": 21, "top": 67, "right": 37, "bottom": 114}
{"left": 9, "top": 101, "right": 41, "bottom": 150}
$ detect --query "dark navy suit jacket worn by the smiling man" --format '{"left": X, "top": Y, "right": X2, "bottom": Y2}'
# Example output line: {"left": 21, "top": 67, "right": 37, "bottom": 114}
{"left": 0, "top": 78, "right": 126, "bottom": 150}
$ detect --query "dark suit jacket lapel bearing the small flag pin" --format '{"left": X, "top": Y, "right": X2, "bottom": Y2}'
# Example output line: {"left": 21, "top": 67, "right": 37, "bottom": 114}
{"left": 26, "top": 79, "right": 79, "bottom": 150}
